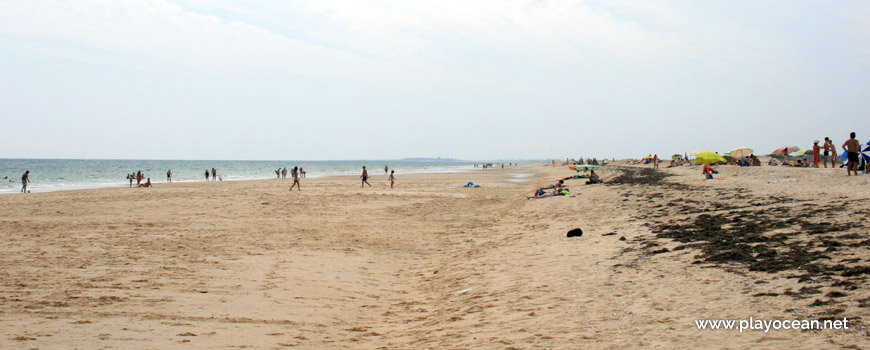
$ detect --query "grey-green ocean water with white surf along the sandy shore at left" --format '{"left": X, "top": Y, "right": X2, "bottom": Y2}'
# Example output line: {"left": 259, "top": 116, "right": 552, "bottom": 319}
{"left": 0, "top": 159, "right": 474, "bottom": 194}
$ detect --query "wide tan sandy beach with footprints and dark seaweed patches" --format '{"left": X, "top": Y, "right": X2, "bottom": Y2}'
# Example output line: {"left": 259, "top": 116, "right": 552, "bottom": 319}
{"left": 0, "top": 164, "right": 870, "bottom": 349}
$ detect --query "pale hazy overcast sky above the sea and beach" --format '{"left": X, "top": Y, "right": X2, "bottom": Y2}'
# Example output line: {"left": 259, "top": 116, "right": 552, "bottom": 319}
{"left": 0, "top": 0, "right": 870, "bottom": 160}
